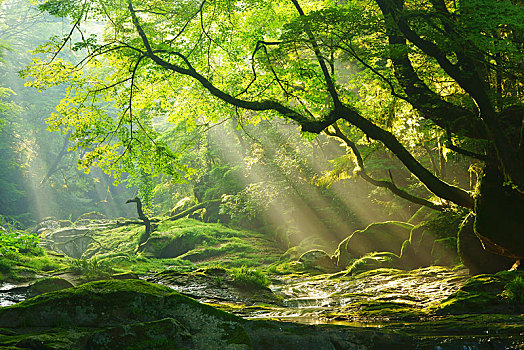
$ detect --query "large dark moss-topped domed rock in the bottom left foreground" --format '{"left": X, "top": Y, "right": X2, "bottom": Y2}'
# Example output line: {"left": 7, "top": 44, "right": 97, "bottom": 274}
{"left": 0, "top": 280, "right": 251, "bottom": 349}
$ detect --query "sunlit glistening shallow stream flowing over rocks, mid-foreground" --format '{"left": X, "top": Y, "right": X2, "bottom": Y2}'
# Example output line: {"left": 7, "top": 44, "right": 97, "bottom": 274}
{"left": 147, "top": 266, "right": 469, "bottom": 327}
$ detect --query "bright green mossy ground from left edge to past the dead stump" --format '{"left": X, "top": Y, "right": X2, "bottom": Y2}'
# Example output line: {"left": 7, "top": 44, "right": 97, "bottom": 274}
{"left": 0, "top": 219, "right": 284, "bottom": 284}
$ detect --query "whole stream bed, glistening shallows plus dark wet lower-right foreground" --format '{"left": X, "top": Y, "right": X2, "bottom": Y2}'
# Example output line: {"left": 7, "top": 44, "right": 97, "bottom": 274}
{"left": 0, "top": 266, "right": 524, "bottom": 350}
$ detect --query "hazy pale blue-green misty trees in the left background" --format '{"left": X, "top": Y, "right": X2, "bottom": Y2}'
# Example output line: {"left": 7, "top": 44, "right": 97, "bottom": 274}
{"left": 0, "top": 0, "right": 138, "bottom": 226}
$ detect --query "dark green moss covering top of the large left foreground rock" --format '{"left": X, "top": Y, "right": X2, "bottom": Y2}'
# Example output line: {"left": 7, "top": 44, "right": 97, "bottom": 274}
{"left": 0, "top": 280, "right": 242, "bottom": 328}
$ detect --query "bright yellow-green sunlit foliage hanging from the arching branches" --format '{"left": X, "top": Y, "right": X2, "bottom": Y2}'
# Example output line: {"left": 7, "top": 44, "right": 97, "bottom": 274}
{"left": 25, "top": 0, "right": 510, "bottom": 216}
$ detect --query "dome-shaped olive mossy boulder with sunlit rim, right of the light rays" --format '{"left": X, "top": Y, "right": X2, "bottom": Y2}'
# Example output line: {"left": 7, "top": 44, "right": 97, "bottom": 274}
{"left": 334, "top": 221, "right": 413, "bottom": 268}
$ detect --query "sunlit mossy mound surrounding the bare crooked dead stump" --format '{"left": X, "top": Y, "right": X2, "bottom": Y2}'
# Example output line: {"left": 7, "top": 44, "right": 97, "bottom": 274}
{"left": 81, "top": 219, "right": 283, "bottom": 274}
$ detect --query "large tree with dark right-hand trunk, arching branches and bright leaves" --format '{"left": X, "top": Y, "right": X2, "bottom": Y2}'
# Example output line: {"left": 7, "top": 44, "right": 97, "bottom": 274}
{"left": 30, "top": 0, "right": 524, "bottom": 270}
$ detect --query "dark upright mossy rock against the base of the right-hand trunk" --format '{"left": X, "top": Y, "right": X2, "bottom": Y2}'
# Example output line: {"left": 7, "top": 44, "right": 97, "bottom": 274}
{"left": 458, "top": 215, "right": 515, "bottom": 275}
